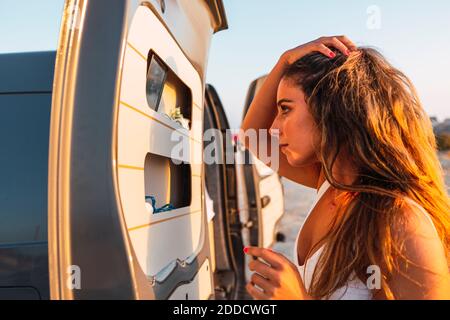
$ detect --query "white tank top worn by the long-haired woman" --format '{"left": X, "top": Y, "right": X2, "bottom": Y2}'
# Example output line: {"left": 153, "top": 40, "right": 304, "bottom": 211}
{"left": 293, "top": 180, "right": 437, "bottom": 300}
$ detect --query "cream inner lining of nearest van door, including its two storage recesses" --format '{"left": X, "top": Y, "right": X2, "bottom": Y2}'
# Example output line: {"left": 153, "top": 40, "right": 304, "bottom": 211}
{"left": 117, "top": 6, "right": 213, "bottom": 300}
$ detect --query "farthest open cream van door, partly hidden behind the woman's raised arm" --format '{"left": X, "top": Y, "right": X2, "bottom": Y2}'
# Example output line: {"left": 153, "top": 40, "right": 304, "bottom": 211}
{"left": 239, "top": 77, "right": 284, "bottom": 248}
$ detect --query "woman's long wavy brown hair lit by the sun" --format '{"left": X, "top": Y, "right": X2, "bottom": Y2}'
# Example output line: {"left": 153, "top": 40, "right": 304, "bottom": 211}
{"left": 284, "top": 47, "right": 450, "bottom": 298}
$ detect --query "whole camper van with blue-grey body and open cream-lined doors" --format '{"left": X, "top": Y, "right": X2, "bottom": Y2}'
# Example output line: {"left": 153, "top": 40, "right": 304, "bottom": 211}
{"left": 0, "top": 0, "right": 284, "bottom": 300}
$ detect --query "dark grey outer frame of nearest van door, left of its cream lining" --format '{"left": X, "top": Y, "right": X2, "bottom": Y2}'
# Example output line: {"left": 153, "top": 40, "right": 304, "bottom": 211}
{"left": 48, "top": 0, "right": 139, "bottom": 299}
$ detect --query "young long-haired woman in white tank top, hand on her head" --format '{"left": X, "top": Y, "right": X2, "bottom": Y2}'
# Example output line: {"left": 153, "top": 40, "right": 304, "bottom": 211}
{"left": 241, "top": 36, "right": 450, "bottom": 299}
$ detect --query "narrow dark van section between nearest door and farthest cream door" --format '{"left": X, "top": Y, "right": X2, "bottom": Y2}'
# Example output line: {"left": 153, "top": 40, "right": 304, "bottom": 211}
{"left": 204, "top": 84, "right": 250, "bottom": 300}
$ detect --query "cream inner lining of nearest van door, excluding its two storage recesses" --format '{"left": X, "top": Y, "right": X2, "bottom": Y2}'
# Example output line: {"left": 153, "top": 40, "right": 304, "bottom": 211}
{"left": 117, "top": 6, "right": 207, "bottom": 280}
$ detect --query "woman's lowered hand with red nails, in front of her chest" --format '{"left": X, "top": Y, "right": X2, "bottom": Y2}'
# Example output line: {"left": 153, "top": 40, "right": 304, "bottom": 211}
{"left": 244, "top": 247, "right": 311, "bottom": 300}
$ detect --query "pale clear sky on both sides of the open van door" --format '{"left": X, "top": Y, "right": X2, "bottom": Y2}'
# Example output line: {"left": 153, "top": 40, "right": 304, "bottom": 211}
{"left": 0, "top": 0, "right": 450, "bottom": 128}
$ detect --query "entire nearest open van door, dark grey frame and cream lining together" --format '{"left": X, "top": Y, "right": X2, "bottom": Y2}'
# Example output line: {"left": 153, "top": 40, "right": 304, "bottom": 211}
{"left": 48, "top": 0, "right": 226, "bottom": 300}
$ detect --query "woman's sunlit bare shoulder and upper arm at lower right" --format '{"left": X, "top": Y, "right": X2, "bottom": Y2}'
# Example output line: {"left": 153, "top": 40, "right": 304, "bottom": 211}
{"left": 380, "top": 199, "right": 450, "bottom": 299}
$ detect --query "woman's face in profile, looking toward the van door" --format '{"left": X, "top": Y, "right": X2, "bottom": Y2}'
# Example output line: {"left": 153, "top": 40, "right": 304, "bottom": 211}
{"left": 270, "top": 79, "right": 319, "bottom": 167}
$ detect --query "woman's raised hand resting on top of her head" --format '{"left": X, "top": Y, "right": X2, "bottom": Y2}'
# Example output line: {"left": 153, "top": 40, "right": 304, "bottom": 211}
{"left": 281, "top": 36, "right": 357, "bottom": 64}
